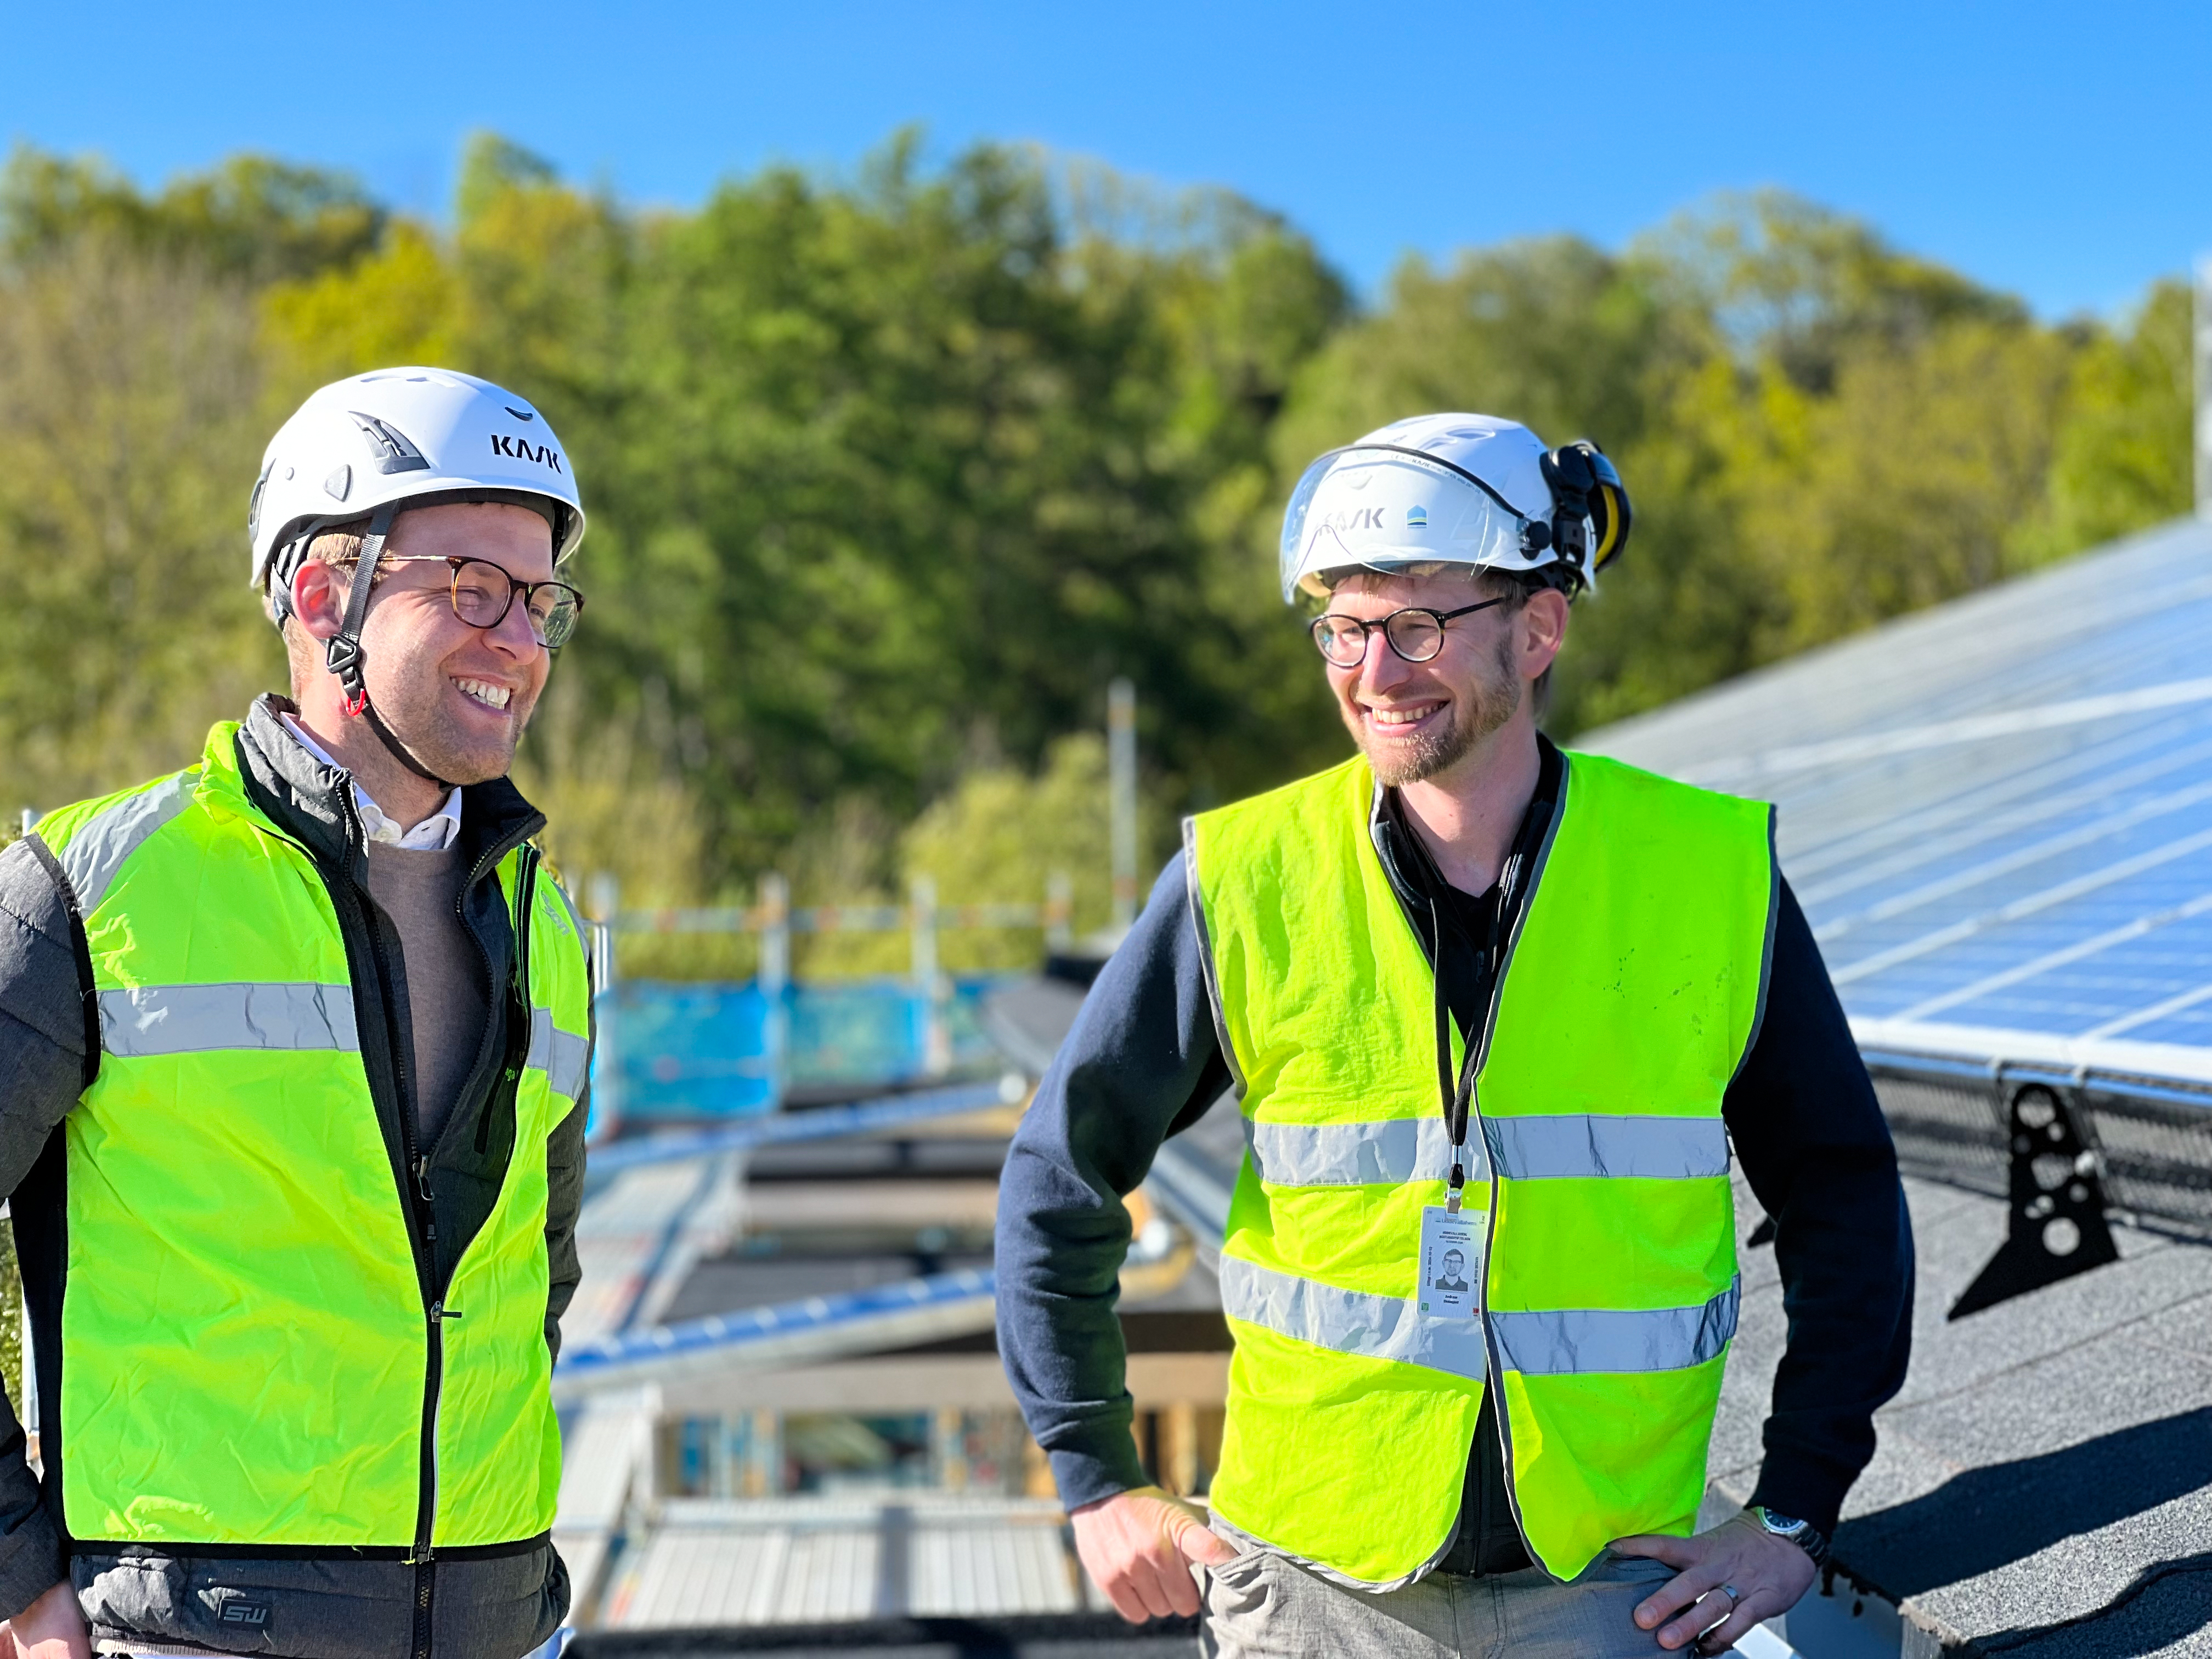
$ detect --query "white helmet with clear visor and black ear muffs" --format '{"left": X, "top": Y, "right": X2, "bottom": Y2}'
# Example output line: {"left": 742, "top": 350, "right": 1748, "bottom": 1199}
{"left": 1281, "top": 414, "right": 1630, "bottom": 604}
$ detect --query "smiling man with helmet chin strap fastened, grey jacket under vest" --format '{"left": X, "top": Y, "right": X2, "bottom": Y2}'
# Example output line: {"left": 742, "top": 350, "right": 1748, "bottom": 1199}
{"left": 0, "top": 369, "right": 591, "bottom": 1659}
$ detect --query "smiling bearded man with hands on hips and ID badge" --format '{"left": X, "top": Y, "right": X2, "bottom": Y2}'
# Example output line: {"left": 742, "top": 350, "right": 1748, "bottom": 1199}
{"left": 997, "top": 414, "right": 1911, "bottom": 1655}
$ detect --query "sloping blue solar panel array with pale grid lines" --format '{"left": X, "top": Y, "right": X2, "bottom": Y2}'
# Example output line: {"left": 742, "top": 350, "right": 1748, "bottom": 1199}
{"left": 1577, "top": 520, "right": 2212, "bottom": 1082}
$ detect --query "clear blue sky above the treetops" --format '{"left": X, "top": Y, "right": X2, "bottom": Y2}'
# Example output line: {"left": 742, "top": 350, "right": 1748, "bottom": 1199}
{"left": 0, "top": 0, "right": 2212, "bottom": 317}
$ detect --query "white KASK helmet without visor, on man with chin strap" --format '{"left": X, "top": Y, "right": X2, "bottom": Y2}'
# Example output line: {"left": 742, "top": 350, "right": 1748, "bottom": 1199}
{"left": 246, "top": 369, "right": 584, "bottom": 608}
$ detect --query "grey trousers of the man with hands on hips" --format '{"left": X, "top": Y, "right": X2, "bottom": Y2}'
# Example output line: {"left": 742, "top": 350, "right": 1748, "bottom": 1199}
{"left": 1205, "top": 1550, "right": 1674, "bottom": 1659}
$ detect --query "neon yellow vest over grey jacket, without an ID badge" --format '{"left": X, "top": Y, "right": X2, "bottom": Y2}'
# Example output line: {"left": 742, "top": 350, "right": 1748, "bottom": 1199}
{"left": 38, "top": 723, "right": 591, "bottom": 1550}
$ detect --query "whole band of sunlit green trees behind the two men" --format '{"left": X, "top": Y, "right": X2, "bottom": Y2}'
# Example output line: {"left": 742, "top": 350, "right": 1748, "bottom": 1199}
{"left": 0, "top": 135, "right": 2190, "bottom": 924}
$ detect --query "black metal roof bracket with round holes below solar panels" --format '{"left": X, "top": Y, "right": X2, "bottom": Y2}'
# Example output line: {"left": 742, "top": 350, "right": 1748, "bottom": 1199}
{"left": 1949, "top": 1079, "right": 2119, "bottom": 1318}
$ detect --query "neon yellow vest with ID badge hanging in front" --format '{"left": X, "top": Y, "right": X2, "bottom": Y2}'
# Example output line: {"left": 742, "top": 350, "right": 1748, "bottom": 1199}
{"left": 1188, "top": 754, "right": 1776, "bottom": 1588}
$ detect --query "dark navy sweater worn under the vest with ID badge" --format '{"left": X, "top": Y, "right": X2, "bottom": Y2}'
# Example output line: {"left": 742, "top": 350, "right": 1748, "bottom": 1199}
{"left": 997, "top": 743, "right": 1914, "bottom": 1573}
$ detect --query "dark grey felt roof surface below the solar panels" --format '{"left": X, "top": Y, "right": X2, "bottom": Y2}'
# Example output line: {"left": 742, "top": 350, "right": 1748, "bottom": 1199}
{"left": 1710, "top": 1179, "right": 2212, "bottom": 1659}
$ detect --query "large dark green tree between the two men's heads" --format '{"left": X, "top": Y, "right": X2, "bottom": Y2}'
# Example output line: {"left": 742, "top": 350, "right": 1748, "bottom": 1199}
{"left": 549, "top": 133, "right": 1340, "bottom": 867}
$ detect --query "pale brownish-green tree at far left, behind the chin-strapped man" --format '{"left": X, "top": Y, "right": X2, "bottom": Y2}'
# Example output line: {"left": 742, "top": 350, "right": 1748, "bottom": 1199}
{"left": 0, "top": 232, "right": 281, "bottom": 812}
